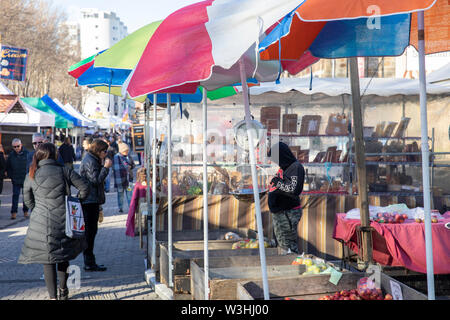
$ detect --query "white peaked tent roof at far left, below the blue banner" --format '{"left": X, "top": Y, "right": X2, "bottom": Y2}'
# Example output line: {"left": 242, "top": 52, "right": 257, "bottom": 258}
{"left": 1, "top": 99, "right": 55, "bottom": 127}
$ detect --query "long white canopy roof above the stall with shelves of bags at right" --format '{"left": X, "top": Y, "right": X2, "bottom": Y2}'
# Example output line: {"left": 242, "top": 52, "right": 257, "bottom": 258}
{"left": 243, "top": 77, "right": 450, "bottom": 96}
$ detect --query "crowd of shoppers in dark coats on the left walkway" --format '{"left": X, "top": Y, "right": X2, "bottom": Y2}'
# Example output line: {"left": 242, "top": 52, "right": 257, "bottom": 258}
{"left": 0, "top": 128, "right": 139, "bottom": 300}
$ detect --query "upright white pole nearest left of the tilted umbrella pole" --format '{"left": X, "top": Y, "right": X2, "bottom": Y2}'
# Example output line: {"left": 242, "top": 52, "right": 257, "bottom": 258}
{"left": 202, "top": 88, "right": 209, "bottom": 300}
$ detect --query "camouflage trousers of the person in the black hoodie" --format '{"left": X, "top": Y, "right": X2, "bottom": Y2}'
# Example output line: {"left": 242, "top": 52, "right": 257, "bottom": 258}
{"left": 272, "top": 209, "right": 302, "bottom": 253}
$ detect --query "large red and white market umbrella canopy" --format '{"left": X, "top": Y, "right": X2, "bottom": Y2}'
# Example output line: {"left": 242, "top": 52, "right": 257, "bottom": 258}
{"left": 127, "top": 0, "right": 302, "bottom": 97}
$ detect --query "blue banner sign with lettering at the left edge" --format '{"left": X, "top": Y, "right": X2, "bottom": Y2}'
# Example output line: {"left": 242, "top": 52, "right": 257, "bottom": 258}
{"left": 0, "top": 46, "right": 28, "bottom": 81}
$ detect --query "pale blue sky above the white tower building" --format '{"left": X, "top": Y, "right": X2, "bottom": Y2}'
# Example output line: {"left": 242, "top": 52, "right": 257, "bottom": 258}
{"left": 48, "top": 0, "right": 200, "bottom": 33}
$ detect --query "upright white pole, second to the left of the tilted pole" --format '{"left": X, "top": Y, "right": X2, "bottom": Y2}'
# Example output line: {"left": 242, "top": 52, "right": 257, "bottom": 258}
{"left": 167, "top": 94, "right": 173, "bottom": 287}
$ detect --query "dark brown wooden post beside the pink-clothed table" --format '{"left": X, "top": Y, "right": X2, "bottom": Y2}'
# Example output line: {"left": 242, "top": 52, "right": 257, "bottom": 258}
{"left": 348, "top": 57, "right": 372, "bottom": 266}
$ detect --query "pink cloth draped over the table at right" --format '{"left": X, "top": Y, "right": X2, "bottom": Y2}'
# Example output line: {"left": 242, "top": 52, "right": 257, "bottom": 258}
{"left": 333, "top": 211, "right": 450, "bottom": 274}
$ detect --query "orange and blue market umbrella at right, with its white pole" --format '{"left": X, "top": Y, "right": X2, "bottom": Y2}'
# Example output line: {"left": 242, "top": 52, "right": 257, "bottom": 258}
{"left": 260, "top": 0, "right": 450, "bottom": 299}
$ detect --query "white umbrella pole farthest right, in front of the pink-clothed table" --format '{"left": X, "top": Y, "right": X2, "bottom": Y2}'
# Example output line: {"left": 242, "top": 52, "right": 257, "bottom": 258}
{"left": 417, "top": 11, "right": 435, "bottom": 300}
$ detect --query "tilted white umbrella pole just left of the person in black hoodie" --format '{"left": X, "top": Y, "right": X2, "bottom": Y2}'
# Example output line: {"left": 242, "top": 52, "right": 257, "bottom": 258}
{"left": 239, "top": 58, "right": 270, "bottom": 300}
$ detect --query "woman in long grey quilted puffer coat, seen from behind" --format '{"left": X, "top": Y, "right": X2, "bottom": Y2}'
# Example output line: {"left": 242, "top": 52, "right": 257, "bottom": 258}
{"left": 18, "top": 143, "right": 89, "bottom": 300}
